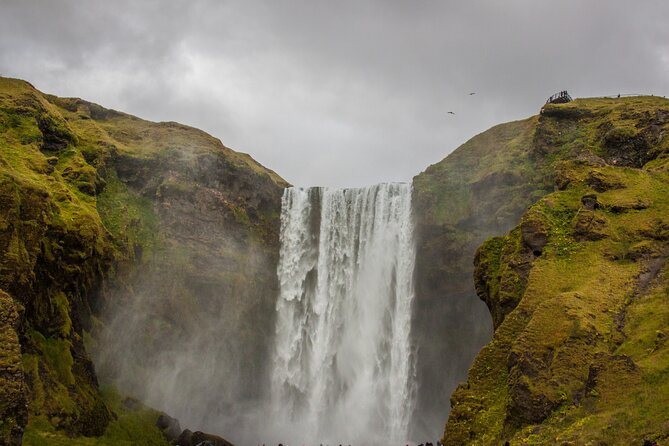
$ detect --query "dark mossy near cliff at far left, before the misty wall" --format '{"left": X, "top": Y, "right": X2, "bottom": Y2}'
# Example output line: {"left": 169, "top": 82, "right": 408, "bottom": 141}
{"left": 0, "top": 79, "right": 113, "bottom": 442}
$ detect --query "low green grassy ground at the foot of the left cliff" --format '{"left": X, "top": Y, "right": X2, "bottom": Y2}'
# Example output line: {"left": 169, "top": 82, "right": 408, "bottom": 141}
{"left": 23, "top": 387, "right": 169, "bottom": 446}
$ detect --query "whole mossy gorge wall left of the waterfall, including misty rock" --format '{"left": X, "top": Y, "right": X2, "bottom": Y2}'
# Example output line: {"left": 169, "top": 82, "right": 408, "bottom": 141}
{"left": 0, "top": 78, "right": 287, "bottom": 444}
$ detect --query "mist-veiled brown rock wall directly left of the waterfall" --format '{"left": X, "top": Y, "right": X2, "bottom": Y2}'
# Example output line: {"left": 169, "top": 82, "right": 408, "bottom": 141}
{"left": 83, "top": 102, "right": 287, "bottom": 435}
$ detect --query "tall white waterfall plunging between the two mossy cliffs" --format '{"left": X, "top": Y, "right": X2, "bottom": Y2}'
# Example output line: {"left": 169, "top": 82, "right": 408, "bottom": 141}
{"left": 271, "top": 184, "right": 415, "bottom": 445}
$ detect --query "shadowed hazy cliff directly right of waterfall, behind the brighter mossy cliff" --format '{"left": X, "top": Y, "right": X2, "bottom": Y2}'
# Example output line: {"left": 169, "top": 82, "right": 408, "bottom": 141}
{"left": 412, "top": 117, "right": 552, "bottom": 436}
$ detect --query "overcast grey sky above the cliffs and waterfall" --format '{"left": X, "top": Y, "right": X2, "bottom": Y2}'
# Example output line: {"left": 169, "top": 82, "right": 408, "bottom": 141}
{"left": 0, "top": 0, "right": 669, "bottom": 187}
